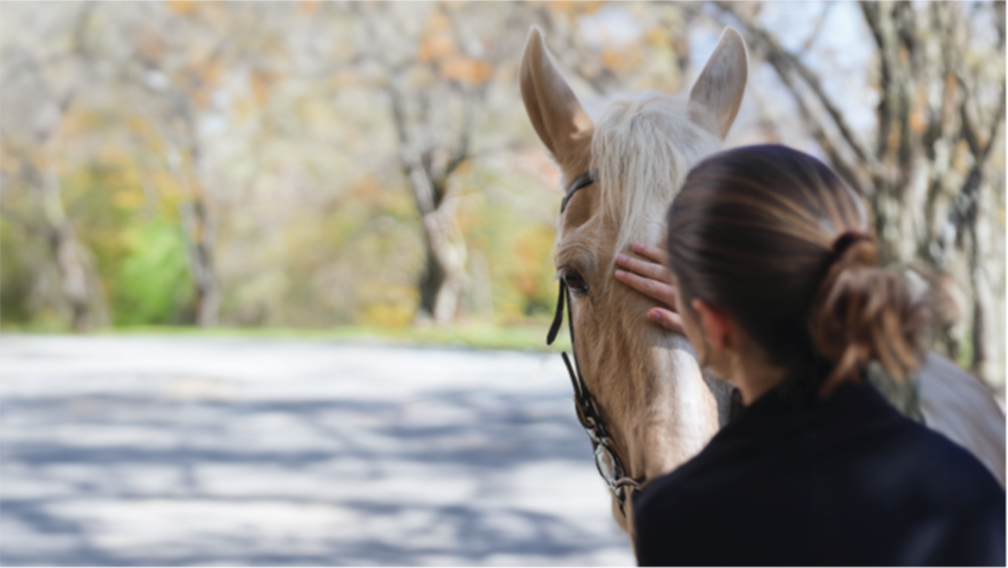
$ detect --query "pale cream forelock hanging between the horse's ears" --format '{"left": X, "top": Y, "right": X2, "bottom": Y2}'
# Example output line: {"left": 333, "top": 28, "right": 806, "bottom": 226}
{"left": 592, "top": 93, "right": 721, "bottom": 252}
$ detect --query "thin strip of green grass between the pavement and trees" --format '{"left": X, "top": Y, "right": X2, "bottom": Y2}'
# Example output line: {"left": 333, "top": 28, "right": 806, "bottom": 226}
{"left": 85, "top": 324, "right": 570, "bottom": 351}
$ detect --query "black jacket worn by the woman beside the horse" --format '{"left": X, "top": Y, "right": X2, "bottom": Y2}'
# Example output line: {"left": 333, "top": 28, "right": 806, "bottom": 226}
{"left": 634, "top": 384, "right": 1008, "bottom": 568}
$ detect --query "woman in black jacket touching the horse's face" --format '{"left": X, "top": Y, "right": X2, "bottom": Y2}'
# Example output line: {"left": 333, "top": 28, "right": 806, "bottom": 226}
{"left": 616, "top": 146, "right": 1008, "bottom": 567}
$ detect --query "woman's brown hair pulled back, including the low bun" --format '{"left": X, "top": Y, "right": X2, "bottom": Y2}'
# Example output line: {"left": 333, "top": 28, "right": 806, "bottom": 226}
{"left": 667, "top": 145, "right": 925, "bottom": 395}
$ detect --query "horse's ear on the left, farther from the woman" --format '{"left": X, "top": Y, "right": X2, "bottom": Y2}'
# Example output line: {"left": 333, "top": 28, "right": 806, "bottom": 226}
{"left": 520, "top": 27, "right": 595, "bottom": 164}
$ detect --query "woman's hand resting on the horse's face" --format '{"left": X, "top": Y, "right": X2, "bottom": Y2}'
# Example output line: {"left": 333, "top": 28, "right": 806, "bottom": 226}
{"left": 616, "top": 242, "right": 682, "bottom": 333}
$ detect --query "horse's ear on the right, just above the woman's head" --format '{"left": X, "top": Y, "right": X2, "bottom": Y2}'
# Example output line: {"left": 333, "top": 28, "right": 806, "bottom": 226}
{"left": 689, "top": 27, "right": 749, "bottom": 138}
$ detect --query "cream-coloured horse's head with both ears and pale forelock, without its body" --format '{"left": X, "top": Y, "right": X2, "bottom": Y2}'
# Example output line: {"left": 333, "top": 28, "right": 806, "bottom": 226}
{"left": 521, "top": 30, "right": 747, "bottom": 535}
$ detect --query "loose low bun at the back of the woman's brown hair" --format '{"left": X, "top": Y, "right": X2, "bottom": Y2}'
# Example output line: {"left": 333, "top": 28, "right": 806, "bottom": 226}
{"left": 808, "top": 231, "right": 925, "bottom": 394}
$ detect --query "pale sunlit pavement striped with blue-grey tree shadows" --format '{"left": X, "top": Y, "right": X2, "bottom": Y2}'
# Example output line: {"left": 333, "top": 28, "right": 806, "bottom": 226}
{"left": 0, "top": 336, "right": 634, "bottom": 568}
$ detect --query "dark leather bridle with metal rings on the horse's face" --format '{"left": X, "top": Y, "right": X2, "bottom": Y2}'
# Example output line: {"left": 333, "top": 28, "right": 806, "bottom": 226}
{"left": 546, "top": 172, "right": 643, "bottom": 516}
